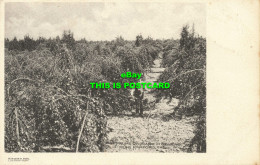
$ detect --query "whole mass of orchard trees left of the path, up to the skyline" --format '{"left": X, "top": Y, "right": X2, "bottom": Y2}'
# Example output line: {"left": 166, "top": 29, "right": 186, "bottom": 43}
{"left": 5, "top": 31, "right": 160, "bottom": 152}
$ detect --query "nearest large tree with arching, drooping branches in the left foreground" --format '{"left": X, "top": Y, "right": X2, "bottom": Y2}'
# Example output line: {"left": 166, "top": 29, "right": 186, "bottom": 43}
{"left": 5, "top": 44, "right": 106, "bottom": 152}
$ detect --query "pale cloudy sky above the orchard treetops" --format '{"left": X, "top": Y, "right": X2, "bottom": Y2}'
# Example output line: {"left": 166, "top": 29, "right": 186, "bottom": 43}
{"left": 5, "top": 2, "right": 206, "bottom": 40}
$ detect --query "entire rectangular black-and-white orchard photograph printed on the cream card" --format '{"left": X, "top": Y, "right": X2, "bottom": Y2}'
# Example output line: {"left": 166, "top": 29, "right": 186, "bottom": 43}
{"left": 4, "top": 2, "right": 207, "bottom": 153}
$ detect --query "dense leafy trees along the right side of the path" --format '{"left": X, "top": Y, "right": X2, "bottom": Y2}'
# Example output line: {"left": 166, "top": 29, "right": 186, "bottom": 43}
{"left": 155, "top": 26, "right": 206, "bottom": 152}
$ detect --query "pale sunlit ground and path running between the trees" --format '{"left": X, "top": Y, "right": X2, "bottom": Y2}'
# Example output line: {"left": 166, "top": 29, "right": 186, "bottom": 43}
{"left": 106, "top": 53, "right": 196, "bottom": 152}
